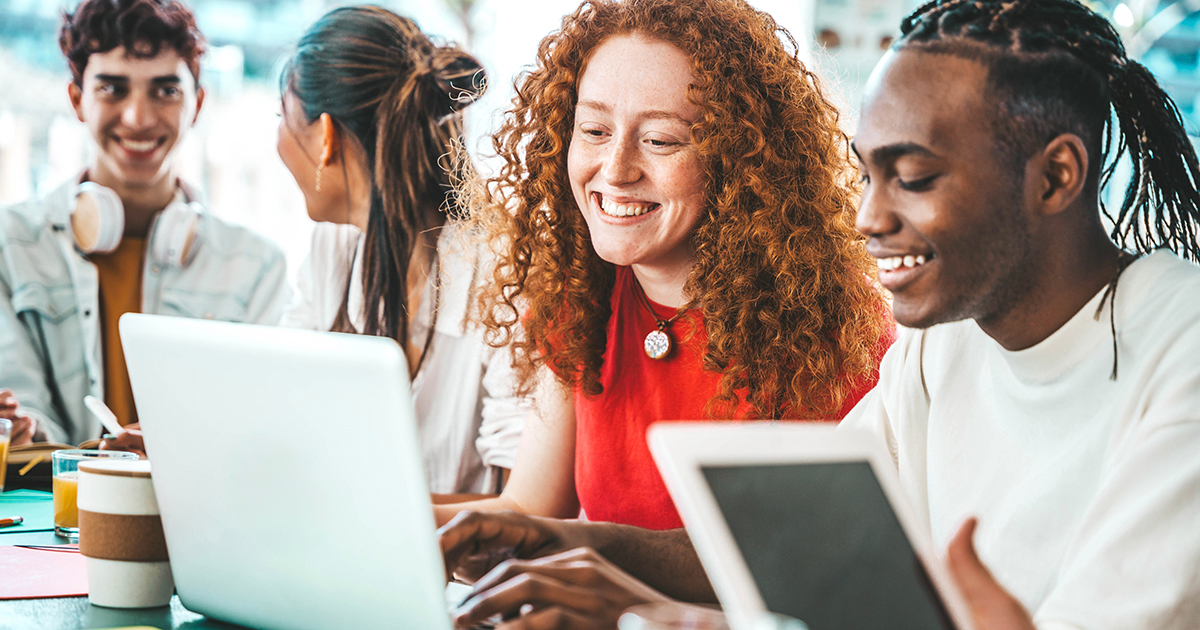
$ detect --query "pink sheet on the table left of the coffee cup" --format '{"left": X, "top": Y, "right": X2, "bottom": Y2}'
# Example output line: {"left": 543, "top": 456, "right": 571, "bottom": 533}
{"left": 0, "top": 545, "right": 88, "bottom": 600}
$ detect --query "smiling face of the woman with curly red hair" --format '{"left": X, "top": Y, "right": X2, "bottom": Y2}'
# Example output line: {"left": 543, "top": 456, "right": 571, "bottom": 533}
{"left": 568, "top": 35, "right": 706, "bottom": 271}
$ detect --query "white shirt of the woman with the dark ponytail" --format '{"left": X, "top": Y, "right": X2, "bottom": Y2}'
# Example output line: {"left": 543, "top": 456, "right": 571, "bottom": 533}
{"left": 283, "top": 223, "right": 535, "bottom": 493}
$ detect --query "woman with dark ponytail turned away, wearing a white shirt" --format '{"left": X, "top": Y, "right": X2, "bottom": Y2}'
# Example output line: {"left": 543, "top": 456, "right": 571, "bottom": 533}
{"left": 278, "top": 6, "right": 526, "bottom": 494}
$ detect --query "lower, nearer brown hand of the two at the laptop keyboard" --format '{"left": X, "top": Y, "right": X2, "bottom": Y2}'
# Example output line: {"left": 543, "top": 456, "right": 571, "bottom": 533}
{"left": 454, "top": 547, "right": 670, "bottom": 630}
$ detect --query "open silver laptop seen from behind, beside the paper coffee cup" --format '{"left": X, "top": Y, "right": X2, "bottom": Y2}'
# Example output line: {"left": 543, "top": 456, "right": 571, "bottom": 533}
{"left": 120, "top": 314, "right": 451, "bottom": 630}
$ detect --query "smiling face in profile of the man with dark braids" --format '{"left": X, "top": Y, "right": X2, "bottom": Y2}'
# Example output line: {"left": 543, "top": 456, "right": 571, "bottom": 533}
{"left": 854, "top": 49, "right": 1033, "bottom": 328}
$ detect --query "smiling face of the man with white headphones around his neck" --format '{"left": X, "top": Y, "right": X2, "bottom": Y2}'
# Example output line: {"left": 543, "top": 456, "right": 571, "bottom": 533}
{"left": 68, "top": 47, "right": 204, "bottom": 186}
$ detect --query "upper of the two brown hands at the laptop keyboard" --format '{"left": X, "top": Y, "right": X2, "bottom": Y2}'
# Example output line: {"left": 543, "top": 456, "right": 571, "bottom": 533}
{"left": 438, "top": 511, "right": 594, "bottom": 582}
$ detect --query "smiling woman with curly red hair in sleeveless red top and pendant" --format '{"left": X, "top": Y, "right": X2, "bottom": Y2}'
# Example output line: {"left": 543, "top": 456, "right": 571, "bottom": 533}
{"left": 438, "top": 0, "right": 892, "bottom": 529}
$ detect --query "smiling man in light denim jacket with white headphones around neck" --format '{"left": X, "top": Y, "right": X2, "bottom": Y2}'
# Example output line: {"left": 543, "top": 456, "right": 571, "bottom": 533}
{"left": 0, "top": 0, "right": 289, "bottom": 444}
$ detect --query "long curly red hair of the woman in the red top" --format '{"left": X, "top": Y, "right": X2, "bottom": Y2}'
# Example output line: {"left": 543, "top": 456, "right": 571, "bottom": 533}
{"left": 476, "top": 0, "right": 890, "bottom": 418}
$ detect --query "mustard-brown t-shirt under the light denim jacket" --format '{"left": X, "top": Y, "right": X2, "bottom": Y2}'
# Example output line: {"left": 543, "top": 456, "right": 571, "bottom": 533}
{"left": 91, "top": 236, "right": 145, "bottom": 426}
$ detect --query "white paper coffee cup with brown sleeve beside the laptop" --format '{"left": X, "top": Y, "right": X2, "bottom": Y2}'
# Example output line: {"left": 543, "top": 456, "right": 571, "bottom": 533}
{"left": 79, "top": 460, "right": 175, "bottom": 608}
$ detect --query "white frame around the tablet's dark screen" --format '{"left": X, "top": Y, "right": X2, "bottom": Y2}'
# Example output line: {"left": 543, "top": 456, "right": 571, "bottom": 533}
{"left": 647, "top": 421, "right": 973, "bottom": 630}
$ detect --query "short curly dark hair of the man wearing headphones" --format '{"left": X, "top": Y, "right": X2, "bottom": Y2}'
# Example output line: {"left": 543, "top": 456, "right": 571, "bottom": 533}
{"left": 59, "top": 0, "right": 204, "bottom": 85}
